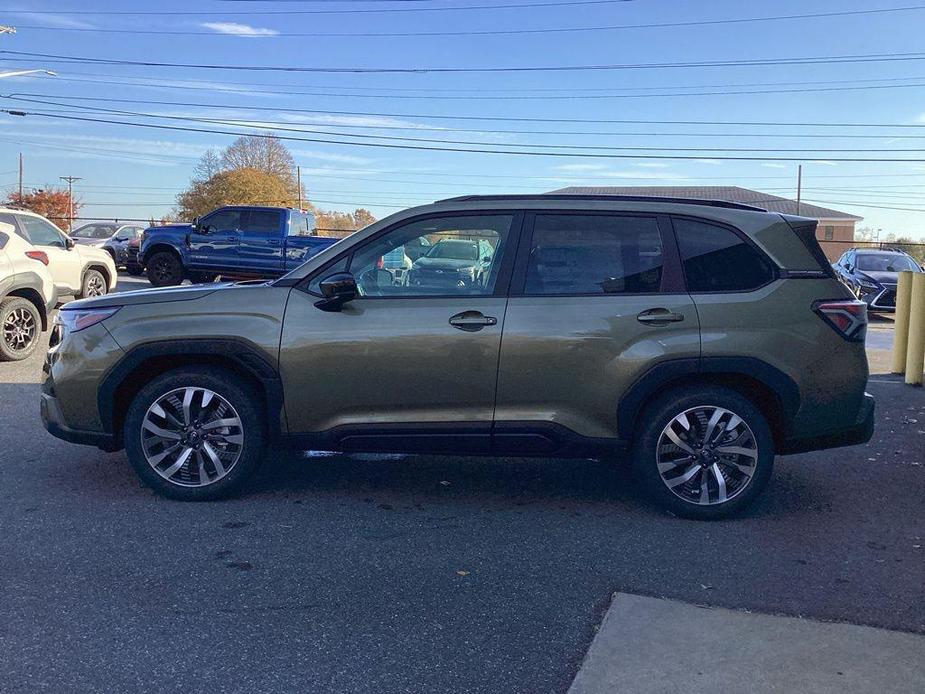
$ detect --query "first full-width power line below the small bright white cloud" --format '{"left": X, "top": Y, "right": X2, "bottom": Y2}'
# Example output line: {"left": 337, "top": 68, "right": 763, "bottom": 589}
{"left": 9, "top": 50, "right": 925, "bottom": 74}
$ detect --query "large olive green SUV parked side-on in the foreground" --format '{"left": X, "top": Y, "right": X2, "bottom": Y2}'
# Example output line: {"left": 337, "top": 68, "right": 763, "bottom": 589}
{"left": 41, "top": 195, "right": 874, "bottom": 518}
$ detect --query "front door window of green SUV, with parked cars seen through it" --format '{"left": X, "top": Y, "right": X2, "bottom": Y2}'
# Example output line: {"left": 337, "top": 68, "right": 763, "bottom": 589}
{"left": 342, "top": 215, "right": 513, "bottom": 296}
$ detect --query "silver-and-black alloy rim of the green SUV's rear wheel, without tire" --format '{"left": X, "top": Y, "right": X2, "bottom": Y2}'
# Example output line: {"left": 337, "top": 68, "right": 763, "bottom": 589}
{"left": 656, "top": 405, "right": 758, "bottom": 506}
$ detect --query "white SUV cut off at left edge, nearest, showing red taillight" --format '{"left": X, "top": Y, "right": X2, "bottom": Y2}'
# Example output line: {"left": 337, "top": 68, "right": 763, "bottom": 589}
{"left": 0, "top": 222, "right": 57, "bottom": 361}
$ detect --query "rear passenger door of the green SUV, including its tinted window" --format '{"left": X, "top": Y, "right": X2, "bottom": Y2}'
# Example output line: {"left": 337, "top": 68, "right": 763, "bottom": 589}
{"left": 493, "top": 212, "right": 700, "bottom": 454}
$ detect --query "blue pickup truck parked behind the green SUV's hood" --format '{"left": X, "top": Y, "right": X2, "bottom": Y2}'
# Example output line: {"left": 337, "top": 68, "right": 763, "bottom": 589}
{"left": 138, "top": 206, "right": 338, "bottom": 287}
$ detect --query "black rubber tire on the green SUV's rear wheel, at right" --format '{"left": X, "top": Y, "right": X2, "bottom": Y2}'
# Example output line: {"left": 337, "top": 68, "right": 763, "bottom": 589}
{"left": 633, "top": 385, "right": 774, "bottom": 520}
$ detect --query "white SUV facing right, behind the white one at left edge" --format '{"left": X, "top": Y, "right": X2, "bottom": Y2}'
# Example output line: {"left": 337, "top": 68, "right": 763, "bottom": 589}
{"left": 0, "top": 207, "right": 117, "bottom": 298}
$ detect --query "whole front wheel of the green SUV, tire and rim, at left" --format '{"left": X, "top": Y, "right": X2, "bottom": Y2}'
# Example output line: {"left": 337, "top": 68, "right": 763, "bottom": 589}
{"left": 124, "top": 367, "right": 266, "bottom": 501}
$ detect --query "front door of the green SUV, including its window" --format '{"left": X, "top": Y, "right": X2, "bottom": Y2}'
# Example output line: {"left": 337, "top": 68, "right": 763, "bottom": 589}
{"left": 280, "top": 212, "right": 521, "bottom": 452}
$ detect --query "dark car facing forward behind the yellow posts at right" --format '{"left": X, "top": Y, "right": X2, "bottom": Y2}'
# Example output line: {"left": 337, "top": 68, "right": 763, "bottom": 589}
{"left": 833, "top": 248, "right": 922, "bottom": 313}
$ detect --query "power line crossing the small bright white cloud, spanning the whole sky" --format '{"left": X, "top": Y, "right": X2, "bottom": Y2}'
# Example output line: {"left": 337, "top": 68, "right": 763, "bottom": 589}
{"left": 12, "top": 5, "right": 925, "bottom": 39}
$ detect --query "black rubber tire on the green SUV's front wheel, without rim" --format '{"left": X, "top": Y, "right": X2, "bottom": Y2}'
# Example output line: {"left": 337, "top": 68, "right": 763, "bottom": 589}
{"left": 123, "top": 366, "right": 267, "bottom": 501}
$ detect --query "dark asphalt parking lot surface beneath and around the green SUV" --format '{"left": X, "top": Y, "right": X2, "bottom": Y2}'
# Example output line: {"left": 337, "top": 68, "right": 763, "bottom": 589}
{"left": 0, "top": 278, "right": 925, "bottom": 692}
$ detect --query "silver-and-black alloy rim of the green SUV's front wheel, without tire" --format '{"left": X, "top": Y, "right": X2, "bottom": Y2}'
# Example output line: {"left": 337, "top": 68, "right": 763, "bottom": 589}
{"left": 141, "top": 387, "right": 244, "bottom": 487}
